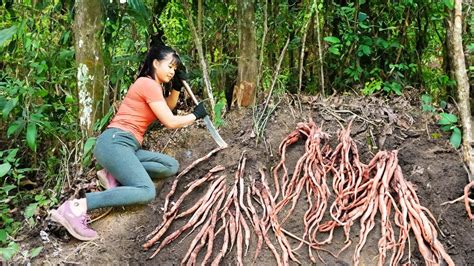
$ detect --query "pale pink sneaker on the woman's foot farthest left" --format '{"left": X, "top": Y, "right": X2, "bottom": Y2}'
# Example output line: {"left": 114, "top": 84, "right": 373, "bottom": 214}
{"left": 50, "top": 200, "right": 98, "bottom": 241}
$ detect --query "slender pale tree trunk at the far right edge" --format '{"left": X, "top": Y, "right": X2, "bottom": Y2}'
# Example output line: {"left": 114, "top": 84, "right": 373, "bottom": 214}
{"left": 448, "top": 0, "right": 474, "bottom": 181}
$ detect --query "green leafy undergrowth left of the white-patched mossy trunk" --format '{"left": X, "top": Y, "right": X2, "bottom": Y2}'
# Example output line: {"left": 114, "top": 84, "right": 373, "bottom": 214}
{"left": 0, "top": 1, "right": 79, "bottom": 251}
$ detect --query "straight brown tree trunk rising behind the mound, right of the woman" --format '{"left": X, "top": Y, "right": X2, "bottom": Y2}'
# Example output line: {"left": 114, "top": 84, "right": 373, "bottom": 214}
{"left": 233, "top": 0, "right": 258, "bottom": 107}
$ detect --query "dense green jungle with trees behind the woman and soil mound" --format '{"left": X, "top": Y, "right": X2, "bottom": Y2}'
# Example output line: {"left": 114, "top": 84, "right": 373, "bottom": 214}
{"left": 0, "top": 0, "right": 474, "bottom": 261}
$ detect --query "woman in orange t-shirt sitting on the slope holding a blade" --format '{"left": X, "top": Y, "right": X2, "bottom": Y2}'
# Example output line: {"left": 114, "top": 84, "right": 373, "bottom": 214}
{"left": 51, "top": 41, "right": 207, "bottom": 241}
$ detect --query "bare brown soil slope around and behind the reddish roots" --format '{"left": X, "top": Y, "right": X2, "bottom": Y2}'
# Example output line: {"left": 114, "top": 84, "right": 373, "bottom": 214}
{"left": 13, "top": 92, "right": 474, "bottom": 265}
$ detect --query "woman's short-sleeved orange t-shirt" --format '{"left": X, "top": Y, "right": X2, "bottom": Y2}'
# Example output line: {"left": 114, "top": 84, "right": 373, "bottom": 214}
{"left": 108, "top": 77, "right": 166, "bottom": 144}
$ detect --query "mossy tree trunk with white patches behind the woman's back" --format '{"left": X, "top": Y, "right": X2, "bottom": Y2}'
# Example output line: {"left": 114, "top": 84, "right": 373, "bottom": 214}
{"left": 73, "top": 0, "right": 109, "bottom": 138}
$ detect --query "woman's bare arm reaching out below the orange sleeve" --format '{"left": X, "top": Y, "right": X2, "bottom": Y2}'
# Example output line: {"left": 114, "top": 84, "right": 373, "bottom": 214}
{"left": 148, "top": 100, "right": 196, "bottom": 129}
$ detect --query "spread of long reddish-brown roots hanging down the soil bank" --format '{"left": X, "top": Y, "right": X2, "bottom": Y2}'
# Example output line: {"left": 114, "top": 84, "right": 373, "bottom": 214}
{"left": 143, "top": 120, "right": 454, "bottom": 265}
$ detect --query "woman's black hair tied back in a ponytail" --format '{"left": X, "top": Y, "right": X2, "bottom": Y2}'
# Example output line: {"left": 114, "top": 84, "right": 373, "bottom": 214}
{"left": 137, "top": 35, "right": 182, "bottom": 79}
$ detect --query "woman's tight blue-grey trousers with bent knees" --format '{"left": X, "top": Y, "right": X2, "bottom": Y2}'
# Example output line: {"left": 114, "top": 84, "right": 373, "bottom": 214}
{"left": 86, "top": 128, "right": 179, "bottom": 210}
